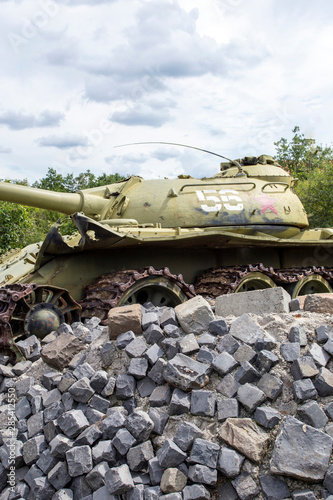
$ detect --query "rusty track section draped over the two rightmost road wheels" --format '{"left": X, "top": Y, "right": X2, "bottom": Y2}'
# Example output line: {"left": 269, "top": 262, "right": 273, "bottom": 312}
{"left": 195, "top": 264, "right": 333, "bottom": 299}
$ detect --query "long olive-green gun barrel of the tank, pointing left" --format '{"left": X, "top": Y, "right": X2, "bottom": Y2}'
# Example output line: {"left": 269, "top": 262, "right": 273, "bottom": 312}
{"left": 0, "top": 182, "right": 109, "bottom": 217}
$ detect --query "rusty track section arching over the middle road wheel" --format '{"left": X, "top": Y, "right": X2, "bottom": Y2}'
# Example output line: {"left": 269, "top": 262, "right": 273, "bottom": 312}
{"left": 80, "top": 266, "right": 196, "bottom": 324}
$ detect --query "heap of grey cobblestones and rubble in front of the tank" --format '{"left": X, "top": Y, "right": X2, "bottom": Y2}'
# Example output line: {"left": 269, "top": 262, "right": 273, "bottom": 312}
{"left": 0, "top": 288, "right": 333, "bottom": 500}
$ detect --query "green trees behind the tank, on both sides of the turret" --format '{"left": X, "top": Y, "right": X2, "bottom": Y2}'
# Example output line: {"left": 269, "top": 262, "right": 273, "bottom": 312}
{"left": 0, "top": 126, "right": 333, "bottom": 255}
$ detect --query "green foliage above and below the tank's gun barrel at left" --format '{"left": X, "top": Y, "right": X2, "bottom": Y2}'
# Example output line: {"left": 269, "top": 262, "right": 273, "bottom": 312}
{"left": 0, "top": 168, "right": 124, "bottom": 255}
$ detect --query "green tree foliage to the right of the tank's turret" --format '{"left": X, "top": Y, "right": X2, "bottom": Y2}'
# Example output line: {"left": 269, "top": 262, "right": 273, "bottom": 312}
{"left": 275, "top": 127, "right": 333, "bottom": 227}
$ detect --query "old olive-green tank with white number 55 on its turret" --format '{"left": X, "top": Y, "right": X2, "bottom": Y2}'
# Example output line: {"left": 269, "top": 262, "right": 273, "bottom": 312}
{"left": 0, "top": 155, "right": 333, "bottom": 352}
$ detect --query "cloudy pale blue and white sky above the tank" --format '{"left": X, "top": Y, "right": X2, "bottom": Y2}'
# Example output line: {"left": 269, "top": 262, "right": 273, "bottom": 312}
{"left": 0, "top": 0, "right": 333, "bottom": 183}
